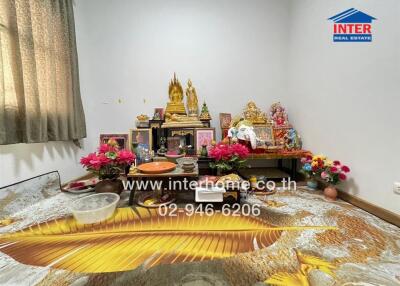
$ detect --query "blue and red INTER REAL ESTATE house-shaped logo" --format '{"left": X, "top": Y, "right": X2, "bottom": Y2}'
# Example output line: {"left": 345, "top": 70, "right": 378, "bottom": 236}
{"left": 328, "top": 8, "right": 376, "bottom": 42}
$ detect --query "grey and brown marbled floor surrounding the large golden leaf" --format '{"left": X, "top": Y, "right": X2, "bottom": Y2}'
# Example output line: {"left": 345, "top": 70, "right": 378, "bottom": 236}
{"left": 0, "top": 173, "right": 400, "bottom": 285}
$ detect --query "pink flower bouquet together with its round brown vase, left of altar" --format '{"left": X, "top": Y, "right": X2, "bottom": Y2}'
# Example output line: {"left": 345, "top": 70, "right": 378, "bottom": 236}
{"left": 80, "top": 138, "right": 135, "bottom": 194}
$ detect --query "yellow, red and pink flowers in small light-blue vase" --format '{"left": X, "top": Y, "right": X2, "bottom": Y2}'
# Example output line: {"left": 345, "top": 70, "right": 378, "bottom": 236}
{"left": 300, "top": 155, "right": 326, "bottom": 190}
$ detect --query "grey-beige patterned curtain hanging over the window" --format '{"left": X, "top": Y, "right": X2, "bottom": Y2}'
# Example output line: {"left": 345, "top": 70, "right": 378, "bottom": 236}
{"left": 0, "top": 0, "right": 86, "bottom": 144}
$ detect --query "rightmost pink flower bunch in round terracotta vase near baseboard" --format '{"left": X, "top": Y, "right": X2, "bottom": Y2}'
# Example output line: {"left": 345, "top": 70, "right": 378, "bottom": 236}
{"left": 320, "top": 161, "right": 350, "bottom": 201}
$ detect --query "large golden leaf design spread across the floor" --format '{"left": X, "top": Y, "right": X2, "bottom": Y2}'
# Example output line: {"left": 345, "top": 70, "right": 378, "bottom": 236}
{"left": 0, "top": 208, "right": 284, "bottom": 273}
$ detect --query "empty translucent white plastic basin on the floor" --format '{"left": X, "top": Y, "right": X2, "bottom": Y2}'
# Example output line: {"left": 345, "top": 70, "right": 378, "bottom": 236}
{"left": 70, "top": 193, "right": 119, "bottom": 224}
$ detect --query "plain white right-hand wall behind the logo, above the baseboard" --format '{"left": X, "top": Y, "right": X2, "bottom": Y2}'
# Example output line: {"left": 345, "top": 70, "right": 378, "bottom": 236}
{"left": 284, "top": 0, "right": 400, "bottom": 213}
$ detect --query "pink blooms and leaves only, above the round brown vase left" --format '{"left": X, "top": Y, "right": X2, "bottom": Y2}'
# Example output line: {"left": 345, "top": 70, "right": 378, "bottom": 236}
{"left": 80, "top": 138, "right": 136, "bottom": 179}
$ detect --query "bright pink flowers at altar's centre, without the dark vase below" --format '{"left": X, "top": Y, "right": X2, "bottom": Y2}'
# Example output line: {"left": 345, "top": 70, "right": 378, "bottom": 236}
{"left": 208, "top": 142, "right": 249, "bottom": 174}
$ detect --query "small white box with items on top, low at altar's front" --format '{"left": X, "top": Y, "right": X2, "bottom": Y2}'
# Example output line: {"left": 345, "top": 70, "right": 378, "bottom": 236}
{"left": 195, "top": 176, "right": 226, "bottom": 203}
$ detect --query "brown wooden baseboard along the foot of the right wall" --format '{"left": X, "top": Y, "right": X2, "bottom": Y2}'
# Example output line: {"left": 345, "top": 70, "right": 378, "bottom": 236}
{"left": 338, "top": 190, "right": 400, "bottom": 227}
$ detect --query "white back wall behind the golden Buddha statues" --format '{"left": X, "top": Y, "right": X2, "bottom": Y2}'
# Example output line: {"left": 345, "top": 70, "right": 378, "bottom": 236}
{"left": 75, "top": 0, "right": 289, "bottom": 145}
